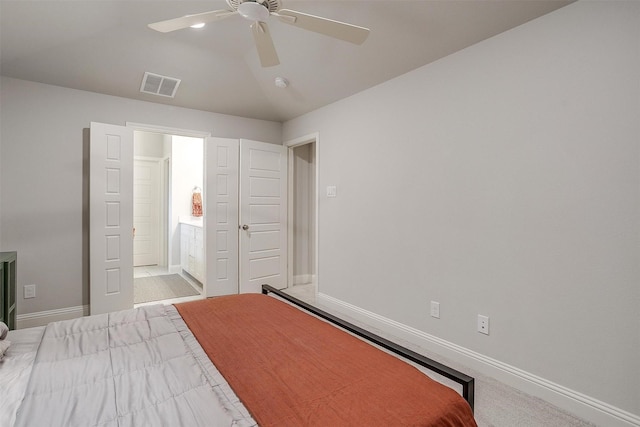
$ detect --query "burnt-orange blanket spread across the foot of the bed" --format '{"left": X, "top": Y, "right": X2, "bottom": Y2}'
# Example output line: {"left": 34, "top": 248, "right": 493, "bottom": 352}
{"left": 176, "top": 294, "right": 476, "bottom": 427}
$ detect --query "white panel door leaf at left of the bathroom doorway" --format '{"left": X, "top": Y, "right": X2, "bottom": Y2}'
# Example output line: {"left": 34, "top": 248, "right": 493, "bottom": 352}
{"left": 89, "top": 123, "right": 133, "bottom": 314}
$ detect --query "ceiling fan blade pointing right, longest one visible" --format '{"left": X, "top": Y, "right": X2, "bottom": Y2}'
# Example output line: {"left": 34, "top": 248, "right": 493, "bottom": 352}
{"left": 272, "top": 9, "right": 369, "bottom": 44}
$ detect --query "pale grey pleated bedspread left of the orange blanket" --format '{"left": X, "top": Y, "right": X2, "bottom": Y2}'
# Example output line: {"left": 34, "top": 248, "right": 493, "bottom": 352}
{"left": 0, "top": 305, "right": 256, "bottom": 427}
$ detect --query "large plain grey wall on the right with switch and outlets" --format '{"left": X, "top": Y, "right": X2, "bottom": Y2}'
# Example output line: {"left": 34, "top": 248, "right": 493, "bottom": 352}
{"left": 283, "top": 1, "right": 640, "bottom": 422}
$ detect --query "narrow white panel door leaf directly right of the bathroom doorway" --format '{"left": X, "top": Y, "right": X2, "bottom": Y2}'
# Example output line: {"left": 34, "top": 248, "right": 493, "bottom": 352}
{"left": 204, "top": 138, "right": 240, "bottom": 297}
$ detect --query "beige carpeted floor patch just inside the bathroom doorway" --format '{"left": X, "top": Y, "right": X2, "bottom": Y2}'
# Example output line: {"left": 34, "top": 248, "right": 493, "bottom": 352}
{"left": 133, "top": 274, "right": 199, "bottom": 304}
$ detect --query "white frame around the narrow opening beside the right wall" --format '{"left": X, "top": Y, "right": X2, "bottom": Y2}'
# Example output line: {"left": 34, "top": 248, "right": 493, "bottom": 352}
{"left": 283, "top": 132, "right": 320, "bottom": 294}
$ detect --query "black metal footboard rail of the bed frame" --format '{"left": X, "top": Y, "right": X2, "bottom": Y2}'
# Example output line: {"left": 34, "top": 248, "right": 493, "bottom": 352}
{"left": 262, "top": 285, "right": 475, "bottom": 411}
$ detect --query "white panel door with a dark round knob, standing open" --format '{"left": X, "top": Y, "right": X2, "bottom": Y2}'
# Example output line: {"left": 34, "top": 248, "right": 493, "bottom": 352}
{"left": 239, "top": 140, "right": 287, "bottom": 293}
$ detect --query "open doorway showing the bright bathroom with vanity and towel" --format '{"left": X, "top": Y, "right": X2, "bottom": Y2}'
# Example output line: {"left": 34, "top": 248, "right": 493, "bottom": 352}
{"left": 133, "top": 131, "right": 205, "bottom": 306}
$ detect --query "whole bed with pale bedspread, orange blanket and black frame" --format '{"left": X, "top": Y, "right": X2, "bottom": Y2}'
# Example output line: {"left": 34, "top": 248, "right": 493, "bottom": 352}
{"left": 0, "top": 286, "right": 476, "bottom": 427}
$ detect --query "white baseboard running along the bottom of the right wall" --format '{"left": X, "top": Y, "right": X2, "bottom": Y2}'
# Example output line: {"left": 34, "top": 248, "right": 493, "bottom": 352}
{"left": 317, "top": 293, "right": 640, "bottom": 427}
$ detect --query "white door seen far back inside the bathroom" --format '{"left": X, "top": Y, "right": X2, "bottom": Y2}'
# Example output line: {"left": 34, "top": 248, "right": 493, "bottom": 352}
{"left": 133, "top": 159, "right": 160, "bottom": 267}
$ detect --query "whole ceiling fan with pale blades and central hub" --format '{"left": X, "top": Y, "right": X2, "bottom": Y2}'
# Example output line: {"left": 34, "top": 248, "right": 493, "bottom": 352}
{"left": 149, "top": 0, "right": 369, "bottom": 67}
